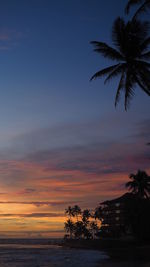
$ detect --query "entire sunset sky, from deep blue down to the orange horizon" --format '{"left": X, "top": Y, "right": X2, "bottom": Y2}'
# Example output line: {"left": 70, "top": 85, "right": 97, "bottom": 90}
{"left": 0, "top": 0, "right": 150, "bottom": 237}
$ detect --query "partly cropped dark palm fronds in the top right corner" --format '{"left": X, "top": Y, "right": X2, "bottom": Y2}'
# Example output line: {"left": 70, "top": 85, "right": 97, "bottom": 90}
{"left": 125, "top": 0, "right": 150, "bottom": 19}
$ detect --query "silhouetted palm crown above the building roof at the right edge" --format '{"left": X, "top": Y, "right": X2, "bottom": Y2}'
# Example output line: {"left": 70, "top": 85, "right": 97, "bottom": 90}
{"left": 126, "top": 170, "right": 150, "bottom": 198}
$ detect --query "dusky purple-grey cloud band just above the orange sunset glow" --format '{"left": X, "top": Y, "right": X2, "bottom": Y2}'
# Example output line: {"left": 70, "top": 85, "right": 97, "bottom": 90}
{"left": 26, "top": 141, "right": 150, "bottom": 175}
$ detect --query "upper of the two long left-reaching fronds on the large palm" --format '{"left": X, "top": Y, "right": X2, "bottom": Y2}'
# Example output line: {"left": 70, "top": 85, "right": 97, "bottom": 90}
{"left": 91, "top": 41, "right": 124, "bottom": 61}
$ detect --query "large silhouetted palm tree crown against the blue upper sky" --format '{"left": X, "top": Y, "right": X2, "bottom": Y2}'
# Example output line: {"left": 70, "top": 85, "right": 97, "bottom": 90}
{"left": 91, "top": 18, "right": 150, "bottom": 110}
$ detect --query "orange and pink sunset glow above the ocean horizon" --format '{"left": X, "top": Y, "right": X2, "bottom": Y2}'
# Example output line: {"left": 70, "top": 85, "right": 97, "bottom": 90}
{"left": 0, "top": 155, "right": 149, "bottom": 237}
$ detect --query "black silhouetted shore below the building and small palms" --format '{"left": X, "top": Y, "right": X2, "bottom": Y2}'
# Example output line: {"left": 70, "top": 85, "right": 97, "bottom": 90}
{"left": 61, "top": 240, "right": 150, "bottom": 262}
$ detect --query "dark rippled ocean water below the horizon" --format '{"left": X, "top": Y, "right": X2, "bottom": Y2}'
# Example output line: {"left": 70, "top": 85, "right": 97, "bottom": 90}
{"left": 0, "top": 242, "right": 108, "bottom": 267}
